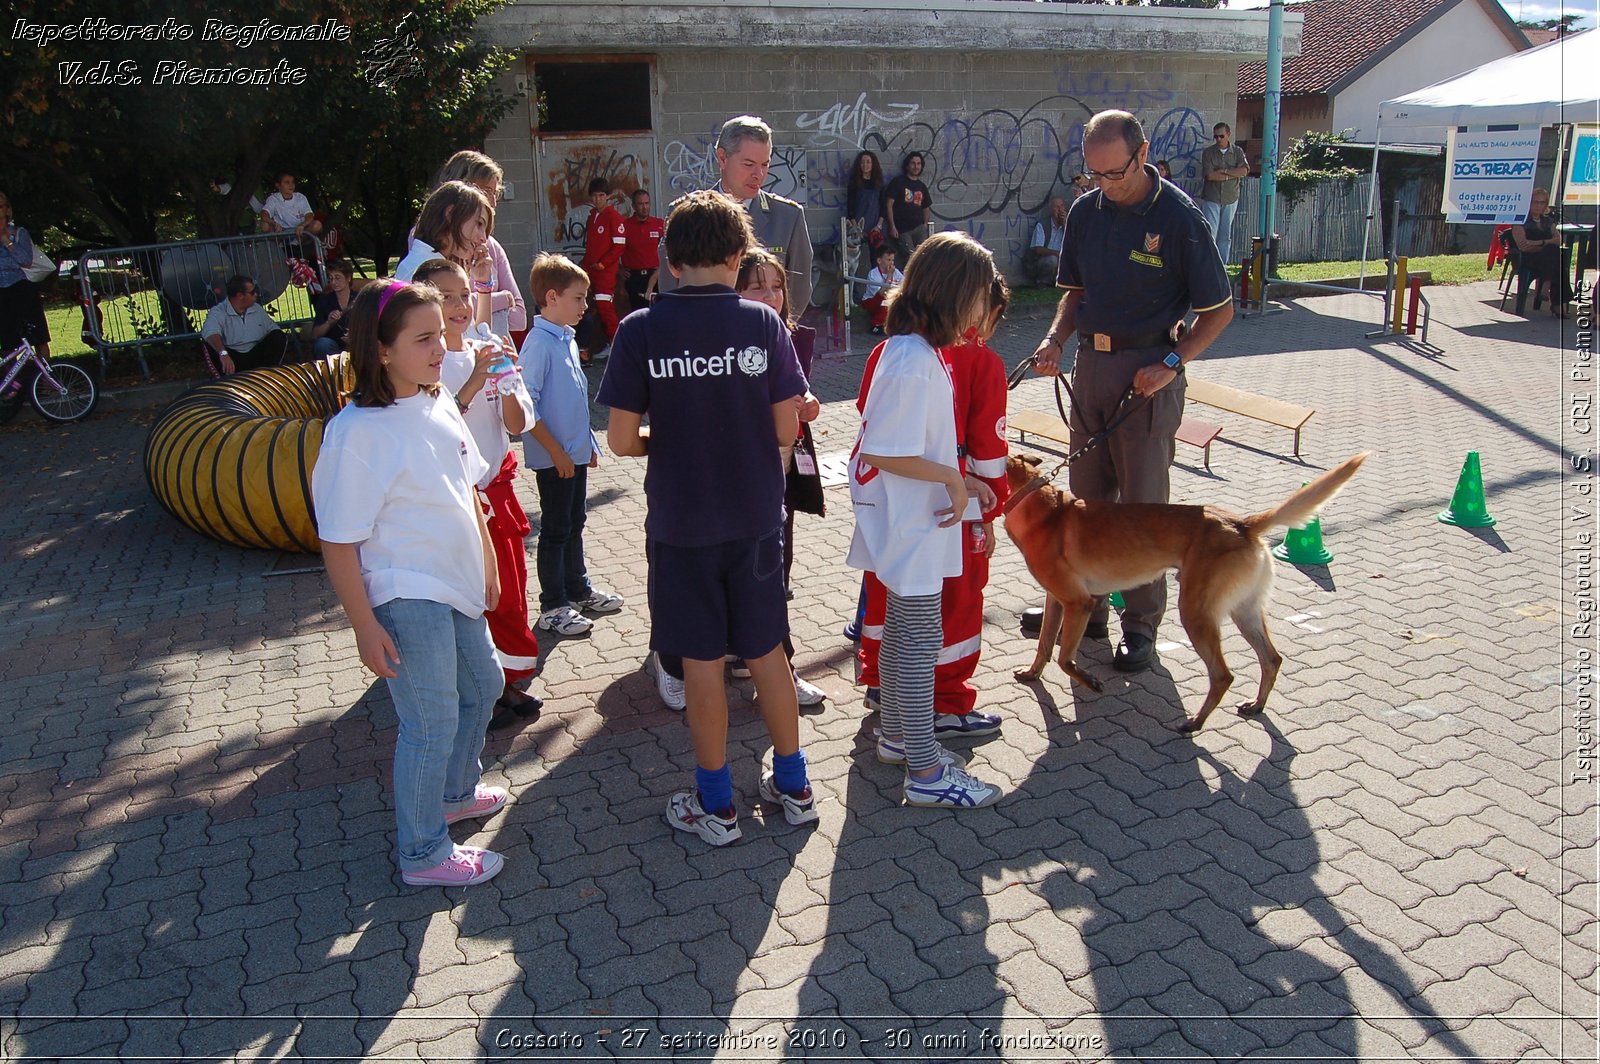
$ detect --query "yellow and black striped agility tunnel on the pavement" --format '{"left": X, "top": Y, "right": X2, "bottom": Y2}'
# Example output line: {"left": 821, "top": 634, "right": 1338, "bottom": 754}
{"left": 144, "top": 354, "right": 354, "bottom": 552}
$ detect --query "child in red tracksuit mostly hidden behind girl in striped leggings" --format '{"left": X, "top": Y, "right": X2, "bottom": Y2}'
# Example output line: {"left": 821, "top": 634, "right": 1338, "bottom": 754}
{"left": 856, "top": 277, "right": 1011, "bottom": 729}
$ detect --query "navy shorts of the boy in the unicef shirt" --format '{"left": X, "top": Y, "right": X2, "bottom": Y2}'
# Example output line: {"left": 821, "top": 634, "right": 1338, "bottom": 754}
{"left": 645, "top": 528, "right": 789, "bottom": 661}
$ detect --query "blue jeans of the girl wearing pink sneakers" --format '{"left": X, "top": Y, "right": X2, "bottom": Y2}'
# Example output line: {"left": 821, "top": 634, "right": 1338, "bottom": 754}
{"left": 373, "top": 598, "right": 506, "bottom": 872}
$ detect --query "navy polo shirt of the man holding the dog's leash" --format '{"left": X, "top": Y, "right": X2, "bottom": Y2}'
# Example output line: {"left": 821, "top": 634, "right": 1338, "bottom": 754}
{"left": 1056, "top": 163, "right": 1234, "bottom": 336}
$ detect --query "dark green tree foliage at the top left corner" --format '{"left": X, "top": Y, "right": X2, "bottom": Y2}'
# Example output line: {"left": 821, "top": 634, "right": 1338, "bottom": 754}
{"left": 0, "top": 0, "right": 515, "bottom": 267}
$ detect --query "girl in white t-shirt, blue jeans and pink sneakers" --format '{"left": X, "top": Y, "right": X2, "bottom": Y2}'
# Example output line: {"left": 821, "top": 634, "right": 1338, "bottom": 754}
{"left": 312, "top": 280, "right": 507, "bottom": 886}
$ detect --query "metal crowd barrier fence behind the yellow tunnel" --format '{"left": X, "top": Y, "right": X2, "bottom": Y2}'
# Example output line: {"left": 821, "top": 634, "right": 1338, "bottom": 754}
{"left": 75, "top": 234, "right": 328, "bottom": 376}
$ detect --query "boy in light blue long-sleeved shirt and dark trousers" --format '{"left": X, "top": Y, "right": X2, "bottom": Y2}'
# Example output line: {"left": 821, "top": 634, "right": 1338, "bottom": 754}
{"left": 522, "top": 254, "right": 622, "bottom": 635}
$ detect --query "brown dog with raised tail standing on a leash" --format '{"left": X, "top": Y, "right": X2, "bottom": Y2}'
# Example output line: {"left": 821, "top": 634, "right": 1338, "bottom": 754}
{"left": 1005, "top": 453, "right": 1366, "bottom": 731}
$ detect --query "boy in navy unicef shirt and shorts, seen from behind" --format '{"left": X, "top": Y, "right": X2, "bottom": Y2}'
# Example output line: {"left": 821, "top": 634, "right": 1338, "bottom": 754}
{"left": 595, "top": 190, "right": 818, "bottom": 846}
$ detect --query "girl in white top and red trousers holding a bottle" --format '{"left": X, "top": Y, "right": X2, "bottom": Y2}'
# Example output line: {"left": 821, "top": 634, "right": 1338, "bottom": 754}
{"left": 413, "top": 259, "right": 542, "bottom": 730}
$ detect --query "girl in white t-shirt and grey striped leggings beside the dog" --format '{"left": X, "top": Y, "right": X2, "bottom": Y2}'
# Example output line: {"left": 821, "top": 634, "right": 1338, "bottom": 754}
{"left": 846, "top": 232, "right": 1000, "bottom": 808}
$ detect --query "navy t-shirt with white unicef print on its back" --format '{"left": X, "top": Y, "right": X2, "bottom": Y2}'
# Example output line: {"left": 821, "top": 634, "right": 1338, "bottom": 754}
{"left": 595, "top": 285, "right": 806, "bottom": 547}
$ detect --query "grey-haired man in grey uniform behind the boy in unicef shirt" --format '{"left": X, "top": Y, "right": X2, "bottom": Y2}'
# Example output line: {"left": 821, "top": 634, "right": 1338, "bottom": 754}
{"left": 656, "top": 115, "right": 811, "bottom": 318}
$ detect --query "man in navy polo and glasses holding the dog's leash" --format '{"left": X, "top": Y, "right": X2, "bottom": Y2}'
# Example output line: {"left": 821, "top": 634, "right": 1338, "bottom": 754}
{"left": 1034, "top": 110, "right": 1234, "bottom": 672}
